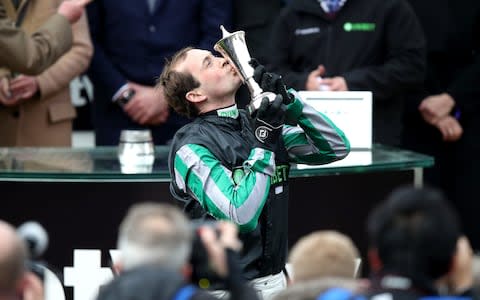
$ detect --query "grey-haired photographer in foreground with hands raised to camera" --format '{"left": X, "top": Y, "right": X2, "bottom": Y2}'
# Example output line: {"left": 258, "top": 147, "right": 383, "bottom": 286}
{"left": 97, "top": 203, "right": 257, "bottom": 300}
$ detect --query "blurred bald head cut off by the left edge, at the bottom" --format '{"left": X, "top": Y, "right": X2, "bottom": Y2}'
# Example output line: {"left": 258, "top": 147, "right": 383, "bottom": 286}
{"left": 0, "top": 221, "right": 27, "bottom": 295}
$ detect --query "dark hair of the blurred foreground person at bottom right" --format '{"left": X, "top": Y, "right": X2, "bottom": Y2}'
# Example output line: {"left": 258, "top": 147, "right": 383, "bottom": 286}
{"left": 367, "top": 187, "right": 461, "bottom": 283}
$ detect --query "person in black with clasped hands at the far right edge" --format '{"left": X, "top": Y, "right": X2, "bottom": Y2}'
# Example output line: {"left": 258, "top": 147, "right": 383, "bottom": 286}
{"left": 403, "top": 0, "right": 480, "bottom": 250}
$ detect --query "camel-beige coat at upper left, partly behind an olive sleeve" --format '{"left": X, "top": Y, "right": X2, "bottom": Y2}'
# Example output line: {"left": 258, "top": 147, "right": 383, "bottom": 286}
{"left": 0, "top": 0, "right": 93, "bottom": 146}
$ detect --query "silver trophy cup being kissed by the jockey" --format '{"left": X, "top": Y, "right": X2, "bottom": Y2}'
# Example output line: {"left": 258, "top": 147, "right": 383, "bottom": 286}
{"left": 213, "top": 25, "right": 276, "bottom": 114}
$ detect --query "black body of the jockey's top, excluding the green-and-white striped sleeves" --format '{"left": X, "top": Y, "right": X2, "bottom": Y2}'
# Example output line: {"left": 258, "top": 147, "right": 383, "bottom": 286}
{"left": 169, "top": 110, "right": 289, "bottom": 280}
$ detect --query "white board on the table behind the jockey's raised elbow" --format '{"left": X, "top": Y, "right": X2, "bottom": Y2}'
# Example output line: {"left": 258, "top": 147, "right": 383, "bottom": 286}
{"left": 299, "top": 91, "right": 373, "bottom": 149}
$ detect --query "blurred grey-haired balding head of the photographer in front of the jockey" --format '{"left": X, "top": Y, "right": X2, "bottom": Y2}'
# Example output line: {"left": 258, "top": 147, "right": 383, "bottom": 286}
{"left": 118, "top": 203, "right": 193, "bottom": 271}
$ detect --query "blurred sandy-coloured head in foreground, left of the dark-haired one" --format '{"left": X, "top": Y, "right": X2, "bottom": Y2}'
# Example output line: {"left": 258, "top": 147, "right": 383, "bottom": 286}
{"left": 289, "top": 230, "right": 359, "bottom": 282}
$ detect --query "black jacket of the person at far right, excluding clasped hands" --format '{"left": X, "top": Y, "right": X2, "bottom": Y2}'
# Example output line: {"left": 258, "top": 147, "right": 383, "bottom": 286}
{"left": 406, "top": 0, "right": 480, "bottom": 134}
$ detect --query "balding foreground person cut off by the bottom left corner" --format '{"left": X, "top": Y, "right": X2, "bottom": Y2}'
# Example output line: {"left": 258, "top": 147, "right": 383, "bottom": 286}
{"left": 0, "top": 220, "right": 44, "bottom": 300}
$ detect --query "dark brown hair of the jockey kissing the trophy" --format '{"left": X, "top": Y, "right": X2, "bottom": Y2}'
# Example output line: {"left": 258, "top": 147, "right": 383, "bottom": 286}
{"left": 157, "top": 47, "right": 200, "bottom": 118}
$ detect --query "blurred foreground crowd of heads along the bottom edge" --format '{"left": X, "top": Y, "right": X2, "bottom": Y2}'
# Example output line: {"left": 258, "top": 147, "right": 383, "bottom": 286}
{"left": 0, "top": 186, "right": 480, "bottom": 300}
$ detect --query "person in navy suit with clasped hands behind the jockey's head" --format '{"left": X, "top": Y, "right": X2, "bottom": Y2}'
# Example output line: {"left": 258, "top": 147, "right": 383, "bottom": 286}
{"left": 87, "top": 0, "right": 232, "bottom": 146}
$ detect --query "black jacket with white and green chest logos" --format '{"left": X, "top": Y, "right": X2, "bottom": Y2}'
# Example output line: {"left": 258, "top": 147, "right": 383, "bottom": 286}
{"left": 269, "top": 0, "right": 425, "bottom": 144}
